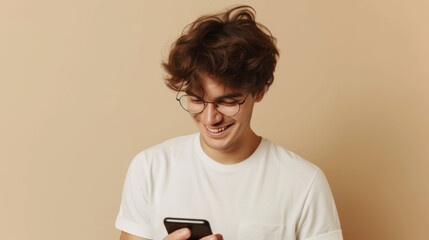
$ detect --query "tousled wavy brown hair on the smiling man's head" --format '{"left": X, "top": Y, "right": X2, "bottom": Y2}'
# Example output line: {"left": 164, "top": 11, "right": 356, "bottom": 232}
{"left": 162, "top": 5, "right": 279, "bottom": 94}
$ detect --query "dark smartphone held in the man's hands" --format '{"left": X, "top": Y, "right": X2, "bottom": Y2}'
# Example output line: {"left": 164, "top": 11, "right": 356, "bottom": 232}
{"left": 164, "top": 217, "right": 213, "bottom": 240}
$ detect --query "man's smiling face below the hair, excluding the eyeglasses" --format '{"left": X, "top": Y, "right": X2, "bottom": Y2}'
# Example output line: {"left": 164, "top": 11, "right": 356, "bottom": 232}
{"left": 191, "top": 77, "right": 263, "bottom": 153}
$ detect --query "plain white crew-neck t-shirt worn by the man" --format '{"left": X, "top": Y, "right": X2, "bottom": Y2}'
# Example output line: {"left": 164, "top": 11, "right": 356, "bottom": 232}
{"left": 116, "top": 133, "right": 343, "bottom": 240}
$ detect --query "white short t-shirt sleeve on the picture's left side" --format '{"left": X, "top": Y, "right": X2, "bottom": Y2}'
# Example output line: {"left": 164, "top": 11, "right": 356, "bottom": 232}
{"left": 115, "top": 153, "right": 153, "bottom": 239}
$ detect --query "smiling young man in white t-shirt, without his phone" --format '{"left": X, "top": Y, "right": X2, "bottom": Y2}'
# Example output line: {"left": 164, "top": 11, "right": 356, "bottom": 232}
{"left": 116, "top": 6, "right": 342, "bottom": 240}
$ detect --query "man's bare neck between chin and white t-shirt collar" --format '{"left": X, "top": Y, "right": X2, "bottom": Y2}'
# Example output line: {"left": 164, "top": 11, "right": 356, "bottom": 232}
{"left": 200, "top": 131, "right": 262, "bottom": 165}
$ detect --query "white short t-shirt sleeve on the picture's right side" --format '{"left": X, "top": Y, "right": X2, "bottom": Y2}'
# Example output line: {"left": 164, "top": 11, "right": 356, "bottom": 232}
{"left": 297, "top": 169, "right": 343, "bottom": 240}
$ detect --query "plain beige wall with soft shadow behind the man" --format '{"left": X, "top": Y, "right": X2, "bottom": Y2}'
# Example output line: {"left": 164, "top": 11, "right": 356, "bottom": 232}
{"left": 0, "top": 0, "right": 429, "bottom": 240}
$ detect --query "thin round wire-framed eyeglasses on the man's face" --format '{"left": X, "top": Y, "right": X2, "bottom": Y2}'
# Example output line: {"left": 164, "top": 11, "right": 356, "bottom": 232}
{"left": 176, "top": 91, "right": 249, "bottom": 117}
